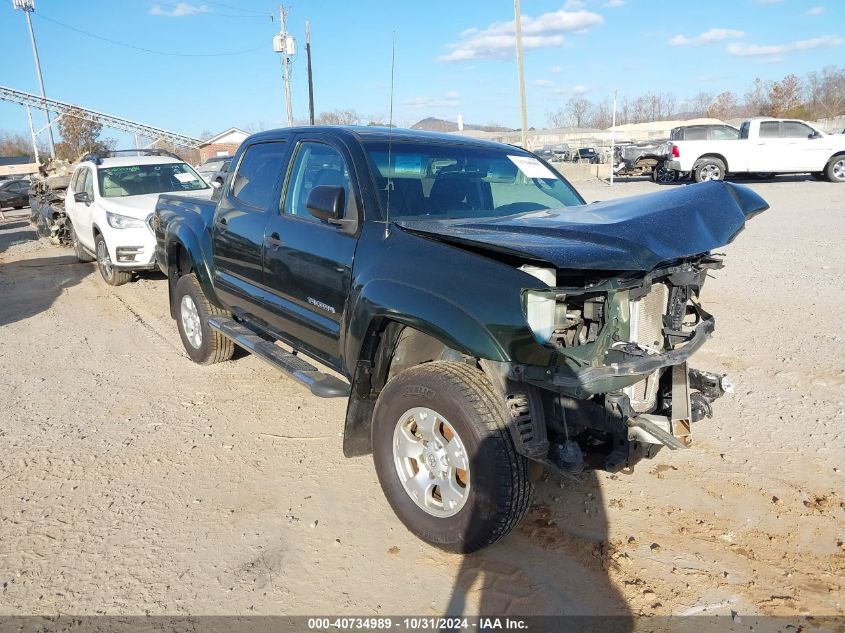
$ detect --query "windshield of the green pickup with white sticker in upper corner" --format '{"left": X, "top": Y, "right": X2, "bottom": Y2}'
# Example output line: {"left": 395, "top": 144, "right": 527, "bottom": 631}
{"left": 364, "top": 141, "right": 584, "bottom": 220}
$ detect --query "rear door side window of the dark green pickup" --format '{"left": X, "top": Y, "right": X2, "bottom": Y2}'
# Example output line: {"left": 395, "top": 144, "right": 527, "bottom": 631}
{"left": 231, "top": 141, "right": 287, "bottom": 210}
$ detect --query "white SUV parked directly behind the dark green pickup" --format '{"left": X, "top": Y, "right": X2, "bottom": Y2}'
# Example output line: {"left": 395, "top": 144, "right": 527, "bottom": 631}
{"left": 65, "top": 150, "right": 213, "bottom": 286}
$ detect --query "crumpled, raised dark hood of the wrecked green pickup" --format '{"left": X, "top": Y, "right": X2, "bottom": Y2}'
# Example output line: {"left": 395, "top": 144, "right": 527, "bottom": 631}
{"left": 397, "top": 182, "right": 769, "bottom": 271}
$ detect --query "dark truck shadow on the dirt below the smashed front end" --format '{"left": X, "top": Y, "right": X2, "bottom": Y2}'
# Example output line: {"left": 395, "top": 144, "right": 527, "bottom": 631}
{"left": 446, "top": 450, "right": 633, "bottom": 633}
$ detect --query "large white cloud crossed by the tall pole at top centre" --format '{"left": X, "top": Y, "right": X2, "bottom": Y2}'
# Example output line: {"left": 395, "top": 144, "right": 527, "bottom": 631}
{"left": 438, "top": 10, "right": 604, "bottom": 62}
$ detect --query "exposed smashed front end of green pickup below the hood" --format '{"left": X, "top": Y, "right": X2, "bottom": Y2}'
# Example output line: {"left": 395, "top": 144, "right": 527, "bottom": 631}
{"left": 506, "top": 255, "right": 731, "bottom": 473}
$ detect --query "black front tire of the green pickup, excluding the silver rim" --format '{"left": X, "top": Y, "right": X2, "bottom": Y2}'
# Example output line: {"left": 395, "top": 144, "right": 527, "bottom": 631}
{"left": 372, "top": 361, "right": 533, "bottom": 553}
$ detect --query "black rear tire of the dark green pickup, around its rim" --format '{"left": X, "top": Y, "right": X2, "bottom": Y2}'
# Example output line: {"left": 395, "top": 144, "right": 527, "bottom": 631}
{"left": 174, "top": 273, "right": 235, "bottom": 365}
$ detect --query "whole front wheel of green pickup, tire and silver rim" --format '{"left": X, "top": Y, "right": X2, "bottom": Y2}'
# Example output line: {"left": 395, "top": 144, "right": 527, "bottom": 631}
{"left": 372, "top": 361, "right": 533, "bottom": 553}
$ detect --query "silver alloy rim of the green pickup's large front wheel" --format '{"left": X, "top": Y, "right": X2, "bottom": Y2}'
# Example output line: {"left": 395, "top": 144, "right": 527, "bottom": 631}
{"left": 393, "top": 407, "right": 470, "bottom": 518}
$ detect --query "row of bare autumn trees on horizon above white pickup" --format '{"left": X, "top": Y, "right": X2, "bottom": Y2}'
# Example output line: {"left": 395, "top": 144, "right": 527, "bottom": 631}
{"left": 547, "top": 66, "right": 845, "bottom": 129}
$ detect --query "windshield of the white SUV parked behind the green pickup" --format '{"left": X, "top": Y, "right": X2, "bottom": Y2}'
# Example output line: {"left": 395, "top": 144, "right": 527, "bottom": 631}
{"left": 97, "top": 163, "right": 208, "bottom": 198}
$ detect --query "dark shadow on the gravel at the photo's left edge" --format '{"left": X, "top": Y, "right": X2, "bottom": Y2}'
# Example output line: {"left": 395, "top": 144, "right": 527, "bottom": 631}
{"left": 0, "top": 252, "right": 94, "bottom": 327}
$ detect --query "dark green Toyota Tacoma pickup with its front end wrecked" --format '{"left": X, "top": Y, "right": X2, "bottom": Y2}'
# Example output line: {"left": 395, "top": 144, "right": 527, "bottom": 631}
{"left": 151, "top": 127, "right": 767, "bottom": 552}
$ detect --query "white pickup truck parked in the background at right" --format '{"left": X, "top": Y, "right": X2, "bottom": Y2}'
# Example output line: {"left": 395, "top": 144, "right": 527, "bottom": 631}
{"left": 665, "top": 118, "right": 845, "bottom": 182}
